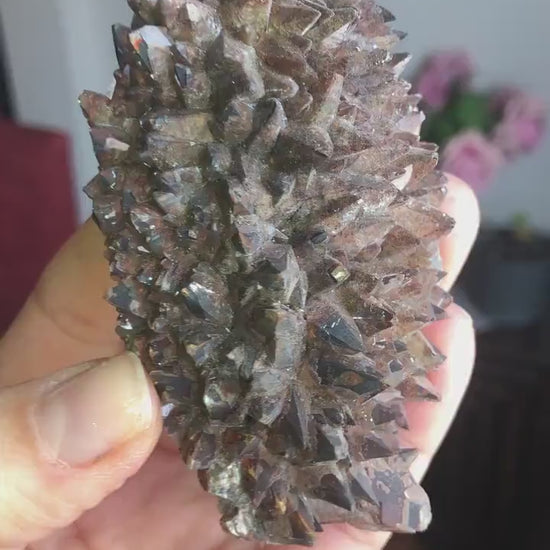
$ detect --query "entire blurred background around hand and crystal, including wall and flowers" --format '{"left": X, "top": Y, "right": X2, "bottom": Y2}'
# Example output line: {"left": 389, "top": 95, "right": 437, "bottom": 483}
{"left": 0, "top": 0, "right": 550, "bottom": 550}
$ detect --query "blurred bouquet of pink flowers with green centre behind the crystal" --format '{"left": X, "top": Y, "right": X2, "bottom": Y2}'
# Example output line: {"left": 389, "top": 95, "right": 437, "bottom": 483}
{"left": 415, "top": 51, "right": 546, "bottom": 196}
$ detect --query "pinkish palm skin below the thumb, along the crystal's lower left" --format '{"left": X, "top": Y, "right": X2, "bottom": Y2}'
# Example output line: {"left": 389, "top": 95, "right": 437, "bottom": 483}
{"left": 41, "top": 441, "right": 260, "bottom": 550}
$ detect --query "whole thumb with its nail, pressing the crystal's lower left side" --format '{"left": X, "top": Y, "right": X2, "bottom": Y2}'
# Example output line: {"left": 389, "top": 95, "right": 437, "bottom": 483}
{"left": 0, "top": 353, "right": 161, "bottom": 548}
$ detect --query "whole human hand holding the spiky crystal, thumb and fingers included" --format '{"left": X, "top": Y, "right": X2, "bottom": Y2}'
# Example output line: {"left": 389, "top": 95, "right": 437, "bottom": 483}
{"left": 0, "top": 179, "right": 479, "bottom": 550}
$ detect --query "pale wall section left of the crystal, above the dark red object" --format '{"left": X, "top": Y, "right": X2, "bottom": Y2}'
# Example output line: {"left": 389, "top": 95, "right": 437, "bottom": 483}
{"left": 0, "top": 0, "right": 131, "bottom": 219}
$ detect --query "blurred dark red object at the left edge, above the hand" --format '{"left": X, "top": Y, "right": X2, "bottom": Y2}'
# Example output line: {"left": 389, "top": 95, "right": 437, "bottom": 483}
{"left": 0, "top": 119, "right": 76, "bottom": 335}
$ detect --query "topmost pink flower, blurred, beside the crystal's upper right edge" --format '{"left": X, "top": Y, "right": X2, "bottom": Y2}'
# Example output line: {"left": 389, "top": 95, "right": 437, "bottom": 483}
{"left": 415, "top": 51, "right": 474, "bottom": 109}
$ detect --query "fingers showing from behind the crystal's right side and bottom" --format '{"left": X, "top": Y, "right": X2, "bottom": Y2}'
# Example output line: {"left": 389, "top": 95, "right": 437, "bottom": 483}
{"left": 315, "top": 182, "right": 480, "bottom": 550}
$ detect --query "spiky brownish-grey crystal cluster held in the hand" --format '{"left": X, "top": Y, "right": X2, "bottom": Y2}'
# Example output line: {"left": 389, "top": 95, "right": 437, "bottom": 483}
{"left": 81, "top": 0, "right": 453, "bottom": 545}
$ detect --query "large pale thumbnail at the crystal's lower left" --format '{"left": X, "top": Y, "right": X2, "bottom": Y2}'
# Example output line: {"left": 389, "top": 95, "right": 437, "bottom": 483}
{"left": 34, "top": 353, "right": 153, "bottom": 467}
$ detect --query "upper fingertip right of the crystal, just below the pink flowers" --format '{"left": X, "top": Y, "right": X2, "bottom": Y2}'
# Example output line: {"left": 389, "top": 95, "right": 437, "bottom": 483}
{"left": 440, "top": 175, "right": 480, "bottom": 290}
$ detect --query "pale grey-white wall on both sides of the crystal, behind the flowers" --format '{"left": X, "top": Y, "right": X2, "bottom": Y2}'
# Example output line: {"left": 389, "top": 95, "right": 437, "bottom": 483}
{"left": 0, "top": 0, "right": 550, "bottom": 231}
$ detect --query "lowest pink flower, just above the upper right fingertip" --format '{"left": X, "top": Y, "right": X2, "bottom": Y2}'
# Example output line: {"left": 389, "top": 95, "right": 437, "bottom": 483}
{"left": 441, "top": 130, "right": 505, "bottom": 192}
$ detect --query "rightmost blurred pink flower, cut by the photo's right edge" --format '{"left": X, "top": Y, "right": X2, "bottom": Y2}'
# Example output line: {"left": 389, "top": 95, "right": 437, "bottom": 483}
{"left": 493, "top": 90, "right": 546, "bottom": 158}
